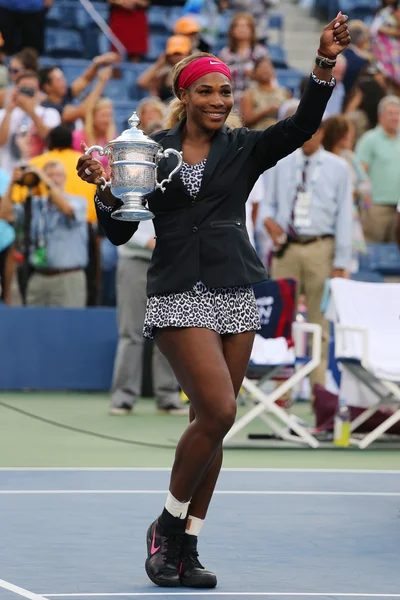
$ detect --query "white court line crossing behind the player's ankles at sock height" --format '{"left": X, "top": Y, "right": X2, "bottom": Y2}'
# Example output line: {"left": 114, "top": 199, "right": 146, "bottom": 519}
{"left": 0, "top": 490, "right": 400, "bottom": 496}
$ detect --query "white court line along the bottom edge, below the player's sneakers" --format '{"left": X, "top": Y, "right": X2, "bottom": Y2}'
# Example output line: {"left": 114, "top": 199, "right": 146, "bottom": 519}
{"left": 39, "top": 591, "right": 400, "bottom": 598}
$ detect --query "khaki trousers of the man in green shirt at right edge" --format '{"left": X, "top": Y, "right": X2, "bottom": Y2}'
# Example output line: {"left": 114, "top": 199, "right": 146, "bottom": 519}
{"left": 361, "top": 205, "right": 400, "bottom": 243}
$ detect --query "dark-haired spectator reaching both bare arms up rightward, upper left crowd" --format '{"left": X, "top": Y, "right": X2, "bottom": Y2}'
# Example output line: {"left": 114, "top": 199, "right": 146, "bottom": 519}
{"left": 39, "top": 52, "right": 118, "bottom": 126}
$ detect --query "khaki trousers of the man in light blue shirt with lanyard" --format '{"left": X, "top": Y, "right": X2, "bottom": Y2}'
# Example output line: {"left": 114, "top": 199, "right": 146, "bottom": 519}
{"left": 271, "top": 238, "right": 335, "bottom": 397}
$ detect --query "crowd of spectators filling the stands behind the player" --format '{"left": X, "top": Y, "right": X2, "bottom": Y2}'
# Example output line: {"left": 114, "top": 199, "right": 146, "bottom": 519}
{"left": 0, "top": 0, "right": 400, "bottom": 404}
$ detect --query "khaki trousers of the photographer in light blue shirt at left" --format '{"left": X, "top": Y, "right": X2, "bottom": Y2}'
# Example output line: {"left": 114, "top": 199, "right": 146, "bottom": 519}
{"left": 26, "top": 269, "right": 86, "bottom": 308}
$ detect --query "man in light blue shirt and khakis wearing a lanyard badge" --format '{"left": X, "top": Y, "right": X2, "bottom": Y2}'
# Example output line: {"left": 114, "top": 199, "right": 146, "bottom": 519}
{"left": 260, "top": 118, "right": 353, "bottom": 398}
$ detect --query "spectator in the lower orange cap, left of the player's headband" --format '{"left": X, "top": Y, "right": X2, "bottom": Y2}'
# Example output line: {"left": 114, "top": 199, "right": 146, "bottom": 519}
{"left": 137, "top": 35, "right": 192, "bottom": 101}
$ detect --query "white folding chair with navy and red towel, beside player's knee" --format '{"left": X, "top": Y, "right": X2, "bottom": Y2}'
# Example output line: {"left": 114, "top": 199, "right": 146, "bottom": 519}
{"left": 224, "top": 279, "right": 322, "bottom": 448}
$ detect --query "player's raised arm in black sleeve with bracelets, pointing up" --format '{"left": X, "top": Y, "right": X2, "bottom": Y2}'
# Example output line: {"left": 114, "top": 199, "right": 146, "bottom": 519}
{"left": 254, "top": 12, "right": 350, "bottom": 173}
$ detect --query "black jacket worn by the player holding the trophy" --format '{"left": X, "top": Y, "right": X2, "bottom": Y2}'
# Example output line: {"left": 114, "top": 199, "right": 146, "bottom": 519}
{"left": 97, "top": 78, "right": 332, "bottom": 296}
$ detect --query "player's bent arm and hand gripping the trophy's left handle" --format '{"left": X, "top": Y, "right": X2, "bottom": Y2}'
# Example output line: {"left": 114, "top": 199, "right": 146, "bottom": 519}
{"left": 76, "top": 142, "right": 139, "bottom": 246}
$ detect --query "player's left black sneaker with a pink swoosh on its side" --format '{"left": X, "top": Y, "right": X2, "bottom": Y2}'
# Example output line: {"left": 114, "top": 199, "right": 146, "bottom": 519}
{"left": 145, "top": 520, "right": 184, "bottom": 587}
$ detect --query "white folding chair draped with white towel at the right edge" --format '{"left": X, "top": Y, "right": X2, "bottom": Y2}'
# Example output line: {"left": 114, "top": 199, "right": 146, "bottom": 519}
{"left": 327, "top": 279, "right": 400, "bottom": 449}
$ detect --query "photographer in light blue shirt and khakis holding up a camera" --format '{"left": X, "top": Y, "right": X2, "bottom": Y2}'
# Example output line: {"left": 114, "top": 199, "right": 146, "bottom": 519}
{"left": 0, "top": 161, "right": 88, "bottom": 308}
